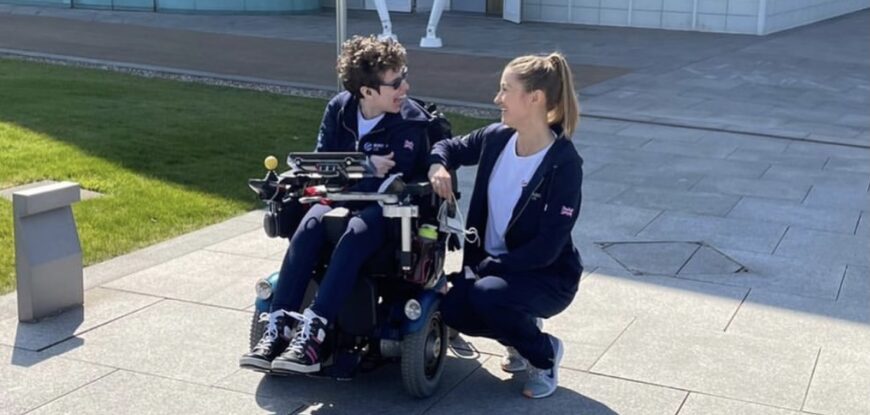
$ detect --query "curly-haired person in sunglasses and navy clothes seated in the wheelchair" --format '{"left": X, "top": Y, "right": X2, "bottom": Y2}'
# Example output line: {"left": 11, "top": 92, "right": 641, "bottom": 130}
{"left": 239, "top": 36, "right": 431, "bottom": 373}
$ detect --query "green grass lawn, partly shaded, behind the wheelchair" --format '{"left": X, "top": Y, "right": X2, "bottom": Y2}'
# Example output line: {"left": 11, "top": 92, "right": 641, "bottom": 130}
{"left": 0, "top": 60, "right": 488, "bottom": 293}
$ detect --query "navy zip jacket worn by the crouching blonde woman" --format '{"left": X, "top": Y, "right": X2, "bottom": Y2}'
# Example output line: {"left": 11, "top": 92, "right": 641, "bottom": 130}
{"left": 429, "top": 123, "right": 583, "bottom": 280}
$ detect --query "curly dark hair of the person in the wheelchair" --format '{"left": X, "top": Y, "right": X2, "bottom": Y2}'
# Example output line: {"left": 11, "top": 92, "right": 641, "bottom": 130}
{"left": 336, "top": 36, "right": 407, "bottom": 98}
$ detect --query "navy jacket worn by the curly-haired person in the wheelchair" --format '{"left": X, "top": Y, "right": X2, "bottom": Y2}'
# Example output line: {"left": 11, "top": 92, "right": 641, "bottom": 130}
{"left": 314, "top": 91, "right": 432, "bottom": 192}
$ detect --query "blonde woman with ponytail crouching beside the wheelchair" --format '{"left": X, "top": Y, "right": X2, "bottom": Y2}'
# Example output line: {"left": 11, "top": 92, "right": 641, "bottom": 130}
{"left": 429, "top": 53, "right": 583, "bottom": 398}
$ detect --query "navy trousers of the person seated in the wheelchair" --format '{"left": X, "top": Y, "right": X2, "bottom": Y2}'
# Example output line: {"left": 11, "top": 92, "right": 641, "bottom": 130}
{"left": 272, "top": 204, "right": 386, "bottom": 320}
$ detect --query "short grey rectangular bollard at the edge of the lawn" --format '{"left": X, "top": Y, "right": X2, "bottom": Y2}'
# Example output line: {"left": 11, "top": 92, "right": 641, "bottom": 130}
{"left": 12, "top": 182, "right": 84, "bottom": 322}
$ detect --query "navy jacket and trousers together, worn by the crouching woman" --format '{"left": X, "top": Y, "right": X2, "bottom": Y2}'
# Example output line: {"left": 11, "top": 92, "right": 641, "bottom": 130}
{"left": 429, "top": 123, "right": 583, "bottom": 368}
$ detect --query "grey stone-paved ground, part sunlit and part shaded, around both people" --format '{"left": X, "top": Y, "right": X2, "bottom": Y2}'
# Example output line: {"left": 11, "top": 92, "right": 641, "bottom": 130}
{"left": 0, "top": 6, "right": 870, "bottom": 415}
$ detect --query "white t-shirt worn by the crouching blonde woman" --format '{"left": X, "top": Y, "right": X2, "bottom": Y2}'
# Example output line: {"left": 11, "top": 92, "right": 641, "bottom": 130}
{"left": 484, "top": 133, "right": 553, "bottom": 256}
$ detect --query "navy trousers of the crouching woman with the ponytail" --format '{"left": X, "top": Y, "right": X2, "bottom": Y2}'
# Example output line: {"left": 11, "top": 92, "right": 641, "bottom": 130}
{"left": 441, "top": 274, "right": 579, "bottom": 369}
